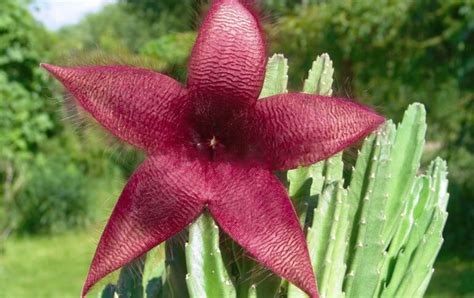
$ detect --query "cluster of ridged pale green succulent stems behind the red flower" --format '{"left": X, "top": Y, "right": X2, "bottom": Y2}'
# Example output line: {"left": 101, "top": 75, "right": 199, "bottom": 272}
{"left": 102, "top": 54, "right": 449, "bottom": 298}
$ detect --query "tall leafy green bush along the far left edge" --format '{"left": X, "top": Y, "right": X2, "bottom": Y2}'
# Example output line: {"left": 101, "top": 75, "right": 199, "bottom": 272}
{"left": 0, "top": 0, "right": 61, "bottom": 237}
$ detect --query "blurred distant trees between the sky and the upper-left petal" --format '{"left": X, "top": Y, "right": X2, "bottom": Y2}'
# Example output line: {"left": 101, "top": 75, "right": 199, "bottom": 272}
{"left": 53, "top": 1, "right": 196, "bottom": 80}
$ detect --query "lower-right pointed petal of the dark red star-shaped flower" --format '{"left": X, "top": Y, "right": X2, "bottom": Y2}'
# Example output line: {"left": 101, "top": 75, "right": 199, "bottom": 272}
{"left": 209, "top": 165, "right": 318, "bottom": 297}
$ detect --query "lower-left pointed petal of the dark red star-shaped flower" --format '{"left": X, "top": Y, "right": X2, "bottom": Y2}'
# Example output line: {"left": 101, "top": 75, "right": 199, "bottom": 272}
{"left": 82, "top": 156, "right": 204, "bottom": 296}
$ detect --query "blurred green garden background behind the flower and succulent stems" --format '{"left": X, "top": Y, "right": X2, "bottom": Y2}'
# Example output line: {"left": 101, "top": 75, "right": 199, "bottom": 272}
{"left": 0, "top": 0, "right": 474, "bottom": 298}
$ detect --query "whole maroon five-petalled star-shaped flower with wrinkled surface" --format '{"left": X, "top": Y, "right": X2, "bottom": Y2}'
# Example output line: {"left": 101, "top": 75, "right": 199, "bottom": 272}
{"left": 43, "top": 0, "right": 384, "bottom": 297}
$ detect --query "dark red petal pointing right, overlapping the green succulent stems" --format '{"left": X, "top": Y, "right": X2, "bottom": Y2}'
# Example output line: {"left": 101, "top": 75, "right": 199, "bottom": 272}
{"left": 254, "top": 93, "right": 384, "bottom": 170}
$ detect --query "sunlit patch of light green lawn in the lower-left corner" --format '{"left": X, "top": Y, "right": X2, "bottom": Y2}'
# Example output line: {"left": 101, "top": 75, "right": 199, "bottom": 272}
{"left": 0, "top": 227, "right": 102, "bottom": 298}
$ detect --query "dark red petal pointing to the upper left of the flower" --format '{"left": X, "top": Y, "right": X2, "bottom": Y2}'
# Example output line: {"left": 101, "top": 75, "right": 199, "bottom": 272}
{"left": 42, "top": 64, "right": 186, "bottom": 149}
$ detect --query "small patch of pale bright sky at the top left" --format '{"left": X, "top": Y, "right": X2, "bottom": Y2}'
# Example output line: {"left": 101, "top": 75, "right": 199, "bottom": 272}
{"left": 30, "top": 0, "right": 116, "bottom": 30}
